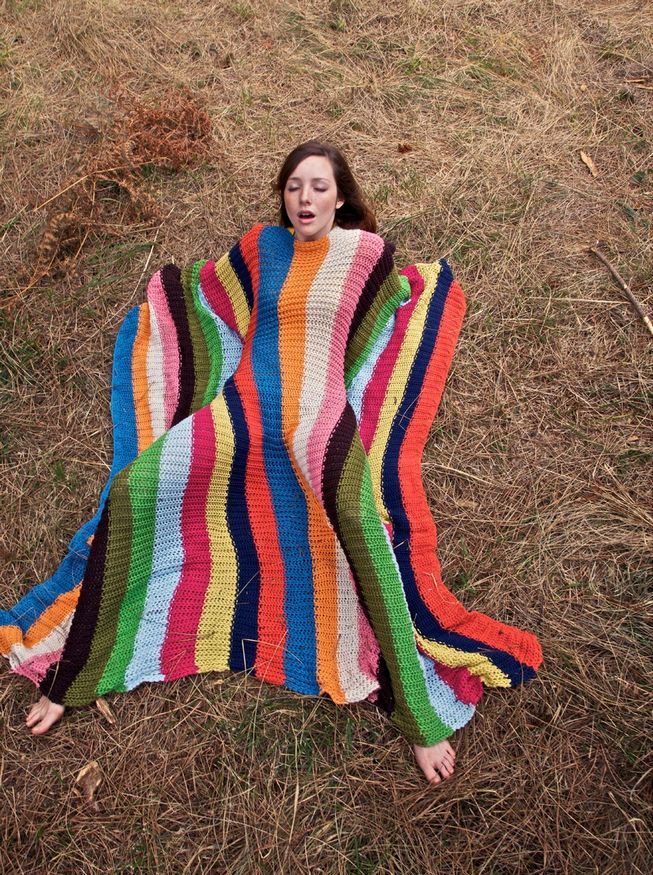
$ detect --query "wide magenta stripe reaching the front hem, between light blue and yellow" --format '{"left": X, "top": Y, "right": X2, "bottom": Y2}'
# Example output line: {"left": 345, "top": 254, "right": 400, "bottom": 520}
{"left": 161, "top": 406, "right": 215, "bottom": 680}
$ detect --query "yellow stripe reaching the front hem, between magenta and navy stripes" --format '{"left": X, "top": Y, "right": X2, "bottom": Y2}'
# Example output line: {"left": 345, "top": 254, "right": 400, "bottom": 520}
{"left": 195, "top": 395, "right": 238, "bottom": 671}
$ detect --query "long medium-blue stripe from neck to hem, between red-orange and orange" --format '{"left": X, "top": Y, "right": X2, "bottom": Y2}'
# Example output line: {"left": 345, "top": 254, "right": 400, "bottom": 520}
{"left": 252, "top": 227, "right": 320, "bottom": 695}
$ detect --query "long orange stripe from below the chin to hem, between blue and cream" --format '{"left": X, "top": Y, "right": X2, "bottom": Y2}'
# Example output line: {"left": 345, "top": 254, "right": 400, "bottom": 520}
{"left": 278, "top": 254, "right": 346, "bottom": 703}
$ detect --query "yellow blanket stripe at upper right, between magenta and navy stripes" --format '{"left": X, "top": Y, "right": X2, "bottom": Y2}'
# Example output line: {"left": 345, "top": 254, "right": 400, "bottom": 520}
{"left": 369, "top": 262, "right": 440, "bottom": 520}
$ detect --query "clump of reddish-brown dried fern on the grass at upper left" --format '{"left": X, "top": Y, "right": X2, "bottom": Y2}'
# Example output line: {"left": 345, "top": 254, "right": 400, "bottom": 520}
{"left": 30, "top": 93, "right": 212, "bottom": 285}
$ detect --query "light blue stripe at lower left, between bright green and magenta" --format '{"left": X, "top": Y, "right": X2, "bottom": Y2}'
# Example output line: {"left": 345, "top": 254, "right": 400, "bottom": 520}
{"left": 125, "top": 416, "right": 193, "bottom": 690}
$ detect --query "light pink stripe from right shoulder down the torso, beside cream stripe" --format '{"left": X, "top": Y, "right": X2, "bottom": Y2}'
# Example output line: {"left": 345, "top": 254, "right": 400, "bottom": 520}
{"left": 307, "top": 234, "right": 384, "bottom": 501}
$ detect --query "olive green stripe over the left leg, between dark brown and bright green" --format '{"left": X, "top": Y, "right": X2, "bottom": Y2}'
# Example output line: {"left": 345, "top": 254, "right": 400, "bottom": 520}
{"left": 66, "top": 466, "right": 132, "bottom": 705}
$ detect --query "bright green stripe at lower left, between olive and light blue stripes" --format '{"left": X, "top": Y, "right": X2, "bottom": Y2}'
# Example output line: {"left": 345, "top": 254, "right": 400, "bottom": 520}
{"left": 98, "top": 435, "right": 166, "bottom": 695}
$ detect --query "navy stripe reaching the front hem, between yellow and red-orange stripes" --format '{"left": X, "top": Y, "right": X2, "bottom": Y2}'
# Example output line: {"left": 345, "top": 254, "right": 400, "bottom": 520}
{"left": 224, "top": 379, "right": 260, "bottom": 671}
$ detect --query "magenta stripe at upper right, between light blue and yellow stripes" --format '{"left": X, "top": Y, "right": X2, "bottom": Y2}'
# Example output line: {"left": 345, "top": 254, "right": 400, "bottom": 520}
{"left": 359, "top": 265, "right": 424, "bottom": 453}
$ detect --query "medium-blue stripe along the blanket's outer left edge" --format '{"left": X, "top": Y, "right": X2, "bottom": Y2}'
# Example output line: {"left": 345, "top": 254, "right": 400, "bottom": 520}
{"left": 0, "top": 307, "right": 139, "bottom": 634}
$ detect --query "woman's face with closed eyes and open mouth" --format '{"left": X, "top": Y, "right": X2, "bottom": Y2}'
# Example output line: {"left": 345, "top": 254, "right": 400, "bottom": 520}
{"left": 283, "top": 155, "right": 344, "bottom": 240}
